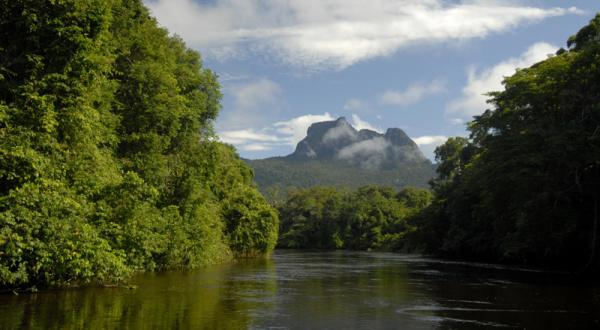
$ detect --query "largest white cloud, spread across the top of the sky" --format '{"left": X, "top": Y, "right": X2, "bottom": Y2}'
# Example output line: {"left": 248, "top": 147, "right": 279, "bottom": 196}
{"left": 145, "top": 0, "right": 580, "bottom": 70}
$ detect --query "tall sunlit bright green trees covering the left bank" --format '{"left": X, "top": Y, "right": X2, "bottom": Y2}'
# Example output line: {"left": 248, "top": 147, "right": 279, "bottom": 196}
{"left": 0, "top": 0, "right": 278, "bottom": 287}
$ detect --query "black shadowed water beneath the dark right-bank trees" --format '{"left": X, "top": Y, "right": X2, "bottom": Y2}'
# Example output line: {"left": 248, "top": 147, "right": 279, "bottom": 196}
{"left": 397, "top": 258, "right": 600, "bottom": 329}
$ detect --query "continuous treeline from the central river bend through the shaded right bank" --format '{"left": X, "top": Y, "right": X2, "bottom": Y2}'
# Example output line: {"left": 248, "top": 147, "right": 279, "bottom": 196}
{"left": 279, "top": 15, "right": 600, "bottom": 271}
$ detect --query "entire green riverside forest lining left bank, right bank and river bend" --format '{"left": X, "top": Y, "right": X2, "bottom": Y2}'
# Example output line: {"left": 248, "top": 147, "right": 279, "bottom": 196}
{"left": 0, "top": 0, "right": 600, "bottom": 289}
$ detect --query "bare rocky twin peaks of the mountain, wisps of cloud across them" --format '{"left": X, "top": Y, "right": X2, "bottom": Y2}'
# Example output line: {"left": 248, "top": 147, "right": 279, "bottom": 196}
{"left": 285, "top": 117, "right": 428, "bottom": 169}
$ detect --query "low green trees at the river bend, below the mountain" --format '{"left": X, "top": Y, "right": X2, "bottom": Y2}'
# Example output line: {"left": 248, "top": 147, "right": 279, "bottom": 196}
{"left": 278, "top": 186, "right": 432, "bottom": 251}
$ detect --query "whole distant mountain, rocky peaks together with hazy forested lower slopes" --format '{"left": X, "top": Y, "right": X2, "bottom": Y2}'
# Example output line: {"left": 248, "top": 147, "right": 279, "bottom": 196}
{"left": 246, "top": 117, "right": 435, "bottom": 196}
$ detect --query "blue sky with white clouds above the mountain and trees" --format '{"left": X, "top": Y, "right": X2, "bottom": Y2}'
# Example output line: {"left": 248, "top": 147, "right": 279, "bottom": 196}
{"left": 144, "top": 0, "right": 600, "bottom": 160}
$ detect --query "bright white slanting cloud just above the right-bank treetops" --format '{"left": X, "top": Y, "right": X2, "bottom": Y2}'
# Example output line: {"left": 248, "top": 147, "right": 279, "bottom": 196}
{"left": 447, "top": 42, "right": 558, "bottom": 118}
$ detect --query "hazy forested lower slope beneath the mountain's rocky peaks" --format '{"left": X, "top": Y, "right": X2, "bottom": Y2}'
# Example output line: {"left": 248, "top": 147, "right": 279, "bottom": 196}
{"left": 247, "top": 157, "right": 435, "bottom": 201}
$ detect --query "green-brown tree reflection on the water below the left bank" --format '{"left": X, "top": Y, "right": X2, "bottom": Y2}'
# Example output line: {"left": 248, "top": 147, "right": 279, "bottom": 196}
{"left": 0, "top": 260, "right": 276, "bottom": 329}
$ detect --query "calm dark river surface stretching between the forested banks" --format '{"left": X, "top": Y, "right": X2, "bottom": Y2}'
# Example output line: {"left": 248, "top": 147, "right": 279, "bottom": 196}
{"left": 0, "top": 251, "right": 600, "bottom": 329}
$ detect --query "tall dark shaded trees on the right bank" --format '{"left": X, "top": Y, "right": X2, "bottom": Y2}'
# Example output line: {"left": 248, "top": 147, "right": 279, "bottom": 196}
{"left": 414, "top": 15, "right": 600, "bottom": 270}
